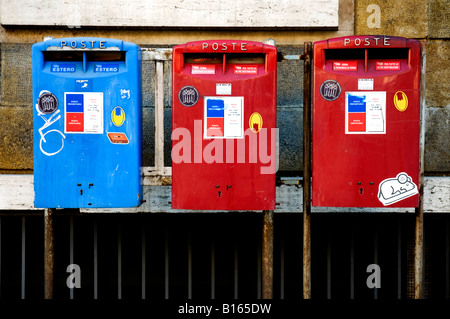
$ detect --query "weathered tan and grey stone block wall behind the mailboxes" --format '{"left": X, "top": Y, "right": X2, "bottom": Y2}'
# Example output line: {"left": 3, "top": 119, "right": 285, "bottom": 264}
{"left": 0, "top": 0, "right": 450, "bottom": 175}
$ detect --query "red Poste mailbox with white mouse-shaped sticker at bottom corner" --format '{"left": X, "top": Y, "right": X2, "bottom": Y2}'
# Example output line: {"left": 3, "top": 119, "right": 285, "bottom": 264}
{"left": 312, "top": 36, "right": 420, "bottom": 207}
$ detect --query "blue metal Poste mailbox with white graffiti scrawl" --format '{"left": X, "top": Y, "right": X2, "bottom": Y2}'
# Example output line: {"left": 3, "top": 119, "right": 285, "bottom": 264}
{"left": 32, "top": 37, "right": 143, "bottom": 208}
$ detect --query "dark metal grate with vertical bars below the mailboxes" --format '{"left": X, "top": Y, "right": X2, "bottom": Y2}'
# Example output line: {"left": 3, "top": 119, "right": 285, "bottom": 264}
{"left": 0, "top": 211, "right": 450, "bottom": 300}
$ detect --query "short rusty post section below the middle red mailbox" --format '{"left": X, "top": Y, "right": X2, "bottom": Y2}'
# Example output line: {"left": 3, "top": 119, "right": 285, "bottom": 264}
{"left": 262, "top": 210, "right": 273, "bottom": 299}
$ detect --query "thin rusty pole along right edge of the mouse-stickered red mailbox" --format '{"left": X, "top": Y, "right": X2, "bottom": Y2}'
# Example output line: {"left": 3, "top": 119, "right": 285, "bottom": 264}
{"left": 414, "top": 41, "right": 426, "bottom": 299}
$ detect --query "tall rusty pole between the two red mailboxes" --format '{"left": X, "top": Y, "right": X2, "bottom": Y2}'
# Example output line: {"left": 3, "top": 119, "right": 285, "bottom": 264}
{"left": 303, "top": 42, "right": 312, "bottom": 299}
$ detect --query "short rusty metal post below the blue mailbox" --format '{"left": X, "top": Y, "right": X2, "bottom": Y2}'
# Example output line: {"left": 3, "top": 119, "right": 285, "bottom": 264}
{"left": 44, "top": 208, "right": 55, "bottom": 299}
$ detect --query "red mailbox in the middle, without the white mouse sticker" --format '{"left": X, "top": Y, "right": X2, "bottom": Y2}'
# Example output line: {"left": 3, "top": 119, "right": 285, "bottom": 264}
{"left": 172, "top": 40, "right": 277, "bottom": 210}
